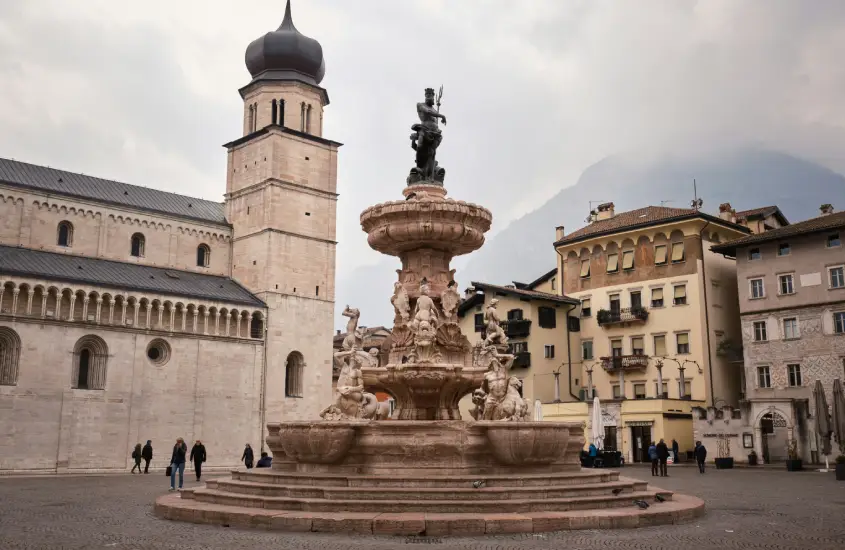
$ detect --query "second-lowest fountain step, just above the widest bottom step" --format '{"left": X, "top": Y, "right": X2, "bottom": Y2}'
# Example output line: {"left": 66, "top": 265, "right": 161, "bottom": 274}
{"left": 186, "top": 489, "right": 671, "bottom": 514}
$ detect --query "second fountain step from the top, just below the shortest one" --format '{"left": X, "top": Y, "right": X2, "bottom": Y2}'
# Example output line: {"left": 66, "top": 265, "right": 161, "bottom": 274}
{"left": 207, "top": 479, "right": 648, "bottom": 500}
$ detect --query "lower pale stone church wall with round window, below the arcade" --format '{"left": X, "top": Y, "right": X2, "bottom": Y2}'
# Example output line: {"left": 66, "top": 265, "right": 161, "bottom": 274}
{"left": 0, "top": 319, "right": 264, "bottom": 473}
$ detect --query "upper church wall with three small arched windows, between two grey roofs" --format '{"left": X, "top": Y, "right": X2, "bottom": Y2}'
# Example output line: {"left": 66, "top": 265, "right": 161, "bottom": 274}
{"left": 0, "top": 186, "right": 231, "bottom": 275}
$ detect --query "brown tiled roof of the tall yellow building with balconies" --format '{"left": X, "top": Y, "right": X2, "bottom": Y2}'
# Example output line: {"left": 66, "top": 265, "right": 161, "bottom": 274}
{"left": 555, "top": 206, "right": 749, "bottom": 246}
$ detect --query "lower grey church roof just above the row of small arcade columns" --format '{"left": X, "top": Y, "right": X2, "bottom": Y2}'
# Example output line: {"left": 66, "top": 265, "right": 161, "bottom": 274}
{"left": 0, "top": 245, "right": 265, "bottom": 307}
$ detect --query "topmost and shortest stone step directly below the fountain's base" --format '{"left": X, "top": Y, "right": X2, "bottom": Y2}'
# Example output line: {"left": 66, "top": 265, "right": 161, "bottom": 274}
{"left": 232, "top": 470, "right": 619, "bottom": 488}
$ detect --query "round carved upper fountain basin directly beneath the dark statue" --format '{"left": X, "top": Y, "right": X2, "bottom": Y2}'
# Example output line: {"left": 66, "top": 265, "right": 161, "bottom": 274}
{"left": 361, "top": 196, "right": 493, "bottom": 256}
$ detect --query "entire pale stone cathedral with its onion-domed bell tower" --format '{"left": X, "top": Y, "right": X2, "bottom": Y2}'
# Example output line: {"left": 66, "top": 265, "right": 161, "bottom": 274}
{"left": 0, "top": 3, "right": 340, "bottom": 474}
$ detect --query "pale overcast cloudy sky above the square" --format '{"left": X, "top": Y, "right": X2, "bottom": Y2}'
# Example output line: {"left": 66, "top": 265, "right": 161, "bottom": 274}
{"left": 0, "top": 0, "right": 845, "bottom": 328}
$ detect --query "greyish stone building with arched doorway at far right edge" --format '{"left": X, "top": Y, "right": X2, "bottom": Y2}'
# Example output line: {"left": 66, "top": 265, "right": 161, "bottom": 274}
{"left": 713, "top": 205, "right": 845, "bottom": 461}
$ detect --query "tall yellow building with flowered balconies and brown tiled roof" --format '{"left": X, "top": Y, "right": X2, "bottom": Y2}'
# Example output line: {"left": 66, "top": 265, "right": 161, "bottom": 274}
{"left": 543, "top": 203, "right": 750, "bottom": 462}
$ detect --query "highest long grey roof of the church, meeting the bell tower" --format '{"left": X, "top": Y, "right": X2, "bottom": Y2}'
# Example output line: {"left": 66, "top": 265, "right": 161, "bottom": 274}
{"left": 0, "top": 158, "right": 228, "bottom": 225}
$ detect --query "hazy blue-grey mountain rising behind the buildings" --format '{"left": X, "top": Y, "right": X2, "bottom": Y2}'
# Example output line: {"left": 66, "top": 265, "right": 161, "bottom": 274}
{"left": 457, "top": 150, "right": 845, "bottom": 286}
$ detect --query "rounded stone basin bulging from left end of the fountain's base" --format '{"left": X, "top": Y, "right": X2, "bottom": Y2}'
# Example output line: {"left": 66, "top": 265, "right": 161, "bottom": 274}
{"left": 268, "top": 421, "right": 367, "bottom": 464}
